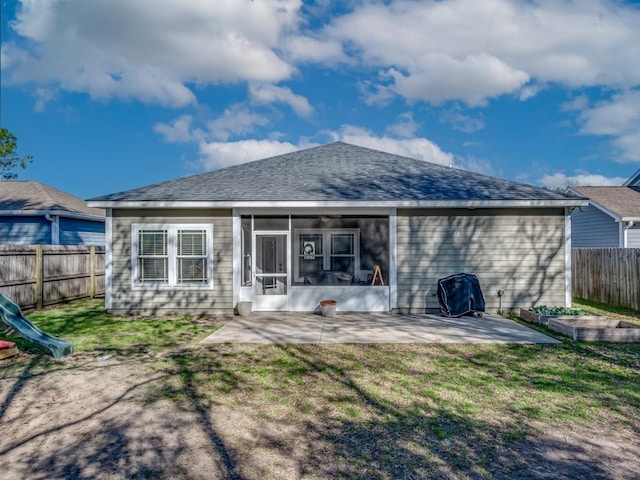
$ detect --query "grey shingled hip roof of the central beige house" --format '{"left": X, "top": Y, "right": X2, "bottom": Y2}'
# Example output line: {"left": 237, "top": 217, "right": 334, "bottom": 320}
{"left": 89, "top": 142, "right": 586, "bottom": 207}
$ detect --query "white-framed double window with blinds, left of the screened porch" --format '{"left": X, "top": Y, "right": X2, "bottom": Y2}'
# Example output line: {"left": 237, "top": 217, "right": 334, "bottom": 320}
{"left": 131, "top": 224, "right": 213, "bottom": 289}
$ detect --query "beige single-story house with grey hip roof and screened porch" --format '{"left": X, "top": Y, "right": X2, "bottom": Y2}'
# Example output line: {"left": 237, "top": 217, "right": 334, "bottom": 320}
{"left": 89, "top": 142, "right": 586, "bottom": 313}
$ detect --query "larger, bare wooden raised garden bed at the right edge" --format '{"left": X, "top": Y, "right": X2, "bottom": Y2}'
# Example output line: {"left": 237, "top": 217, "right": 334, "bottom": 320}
{"left": 548, "top": 316, "right": 640, "bottom": 343}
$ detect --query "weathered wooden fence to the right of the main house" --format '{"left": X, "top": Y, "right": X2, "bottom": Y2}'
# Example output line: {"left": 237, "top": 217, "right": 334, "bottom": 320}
{"left": 571, "top": 248, "right": 640, "bottom": 310}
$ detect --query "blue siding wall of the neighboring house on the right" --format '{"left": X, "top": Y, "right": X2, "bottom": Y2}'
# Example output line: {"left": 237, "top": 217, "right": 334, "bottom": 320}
{"left": 571, "top": 205, "right": 621, "bottom": 248}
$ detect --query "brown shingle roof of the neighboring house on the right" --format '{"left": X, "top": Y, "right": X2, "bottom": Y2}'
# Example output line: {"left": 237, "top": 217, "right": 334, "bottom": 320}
{"left": 569, "top": 187, "right": 640, "bottom": 222}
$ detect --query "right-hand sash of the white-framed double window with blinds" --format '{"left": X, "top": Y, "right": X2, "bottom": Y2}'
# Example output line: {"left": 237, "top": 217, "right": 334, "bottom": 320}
{"left": 177, "top": 230, "right": 208, "bottom": 283}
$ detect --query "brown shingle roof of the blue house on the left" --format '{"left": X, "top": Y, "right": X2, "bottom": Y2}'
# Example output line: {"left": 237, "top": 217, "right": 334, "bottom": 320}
{"left": 0, "top": 180, "right": 105, "bottom": 221}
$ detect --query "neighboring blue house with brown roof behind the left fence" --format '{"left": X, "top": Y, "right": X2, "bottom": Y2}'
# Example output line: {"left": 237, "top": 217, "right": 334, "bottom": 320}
{"left": 0, "top": 180, "right": 105, "bottom": 246}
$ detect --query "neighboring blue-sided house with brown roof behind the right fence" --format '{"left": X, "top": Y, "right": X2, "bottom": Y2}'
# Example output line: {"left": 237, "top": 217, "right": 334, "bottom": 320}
{"left": 567, "top": 187, "right": 640, "bottom": 248}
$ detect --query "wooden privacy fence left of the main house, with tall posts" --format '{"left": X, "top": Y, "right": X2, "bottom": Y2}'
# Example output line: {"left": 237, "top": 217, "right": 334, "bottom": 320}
{"left": 0, "top": 245, "right": 105, "bottom": 310}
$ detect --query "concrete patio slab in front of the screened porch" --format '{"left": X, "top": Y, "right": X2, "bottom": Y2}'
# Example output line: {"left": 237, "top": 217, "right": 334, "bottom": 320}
{"left": 202, "top": 312, "right": 561, "bottom": 344}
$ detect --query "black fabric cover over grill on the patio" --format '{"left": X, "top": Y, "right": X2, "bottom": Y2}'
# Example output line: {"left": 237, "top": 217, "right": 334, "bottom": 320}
{"left": 438, "top": 273, "right": 484, "bottom": 317}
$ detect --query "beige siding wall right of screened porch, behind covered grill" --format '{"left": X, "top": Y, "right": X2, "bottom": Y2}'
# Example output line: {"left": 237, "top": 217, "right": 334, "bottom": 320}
{"left": 397, "top": 209, "right": 566, "bottom": 312}
